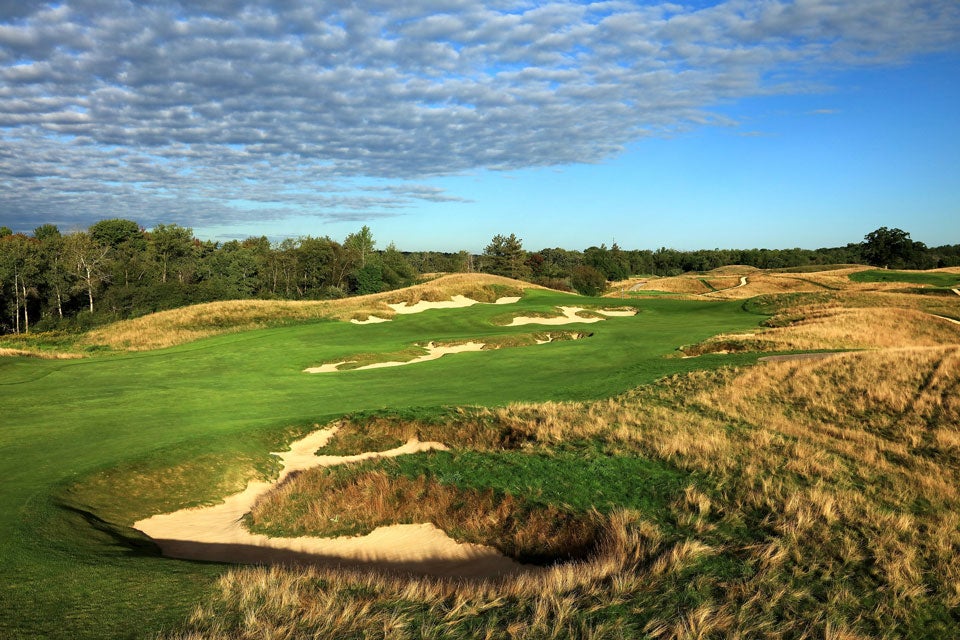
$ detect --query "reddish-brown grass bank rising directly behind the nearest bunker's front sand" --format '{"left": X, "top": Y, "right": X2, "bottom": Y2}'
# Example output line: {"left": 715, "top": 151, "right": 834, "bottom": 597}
{"left": 251, "top": 468, "right": 600, "bottom": 564}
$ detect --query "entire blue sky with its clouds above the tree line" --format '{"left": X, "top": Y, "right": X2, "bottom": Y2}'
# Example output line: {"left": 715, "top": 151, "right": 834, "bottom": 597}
{"left": 0, "top": 0, "right": 960, "bottom": 251}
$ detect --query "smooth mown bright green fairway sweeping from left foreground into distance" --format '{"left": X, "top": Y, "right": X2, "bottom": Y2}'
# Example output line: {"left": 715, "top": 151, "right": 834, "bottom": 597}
{"left": 0, "top": 291, "right": 763, "bottom": 638}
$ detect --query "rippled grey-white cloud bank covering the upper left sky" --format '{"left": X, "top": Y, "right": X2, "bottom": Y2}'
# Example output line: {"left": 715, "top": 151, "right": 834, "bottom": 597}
{"left": 0, "top": 0, "right": 960, "bottom": 228}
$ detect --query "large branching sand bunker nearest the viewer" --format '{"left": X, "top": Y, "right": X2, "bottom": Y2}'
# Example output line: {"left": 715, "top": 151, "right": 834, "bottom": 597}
{"left": 133, "top": 428, "right": 528, "bottom": 577}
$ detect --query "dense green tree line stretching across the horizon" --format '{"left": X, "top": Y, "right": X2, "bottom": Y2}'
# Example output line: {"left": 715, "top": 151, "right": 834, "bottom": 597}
{"left": 0, "top": 219, "right": 960, "bottom": 334}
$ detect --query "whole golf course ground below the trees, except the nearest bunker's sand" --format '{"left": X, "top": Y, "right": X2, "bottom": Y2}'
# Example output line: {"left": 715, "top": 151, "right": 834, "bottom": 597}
{"left": 0, "top": 267, "right": 960, "bottom": 639}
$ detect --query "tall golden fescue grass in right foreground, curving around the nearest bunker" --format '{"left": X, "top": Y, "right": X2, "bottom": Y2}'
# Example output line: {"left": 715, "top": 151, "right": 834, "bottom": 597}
{"left": 170, "top": 346, "right": 960, "bottom": 638}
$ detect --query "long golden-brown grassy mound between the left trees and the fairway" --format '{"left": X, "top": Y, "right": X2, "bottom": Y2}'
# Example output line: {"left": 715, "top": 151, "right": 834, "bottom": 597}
{"left": 83, "top": 273, "right": 537, "bottom": 351}
